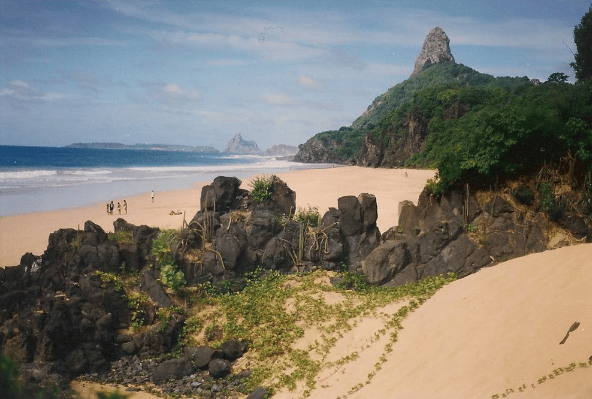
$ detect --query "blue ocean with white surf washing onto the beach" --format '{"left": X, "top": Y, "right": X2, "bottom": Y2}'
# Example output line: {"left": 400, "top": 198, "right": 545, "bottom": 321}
{"left": 0, "top": 146, "right": 332, "bottom": 216}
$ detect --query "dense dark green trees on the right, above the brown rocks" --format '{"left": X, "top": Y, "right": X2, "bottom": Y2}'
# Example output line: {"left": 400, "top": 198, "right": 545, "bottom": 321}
{"left": 408, "top": 77, "right": 592, "bottom": 193}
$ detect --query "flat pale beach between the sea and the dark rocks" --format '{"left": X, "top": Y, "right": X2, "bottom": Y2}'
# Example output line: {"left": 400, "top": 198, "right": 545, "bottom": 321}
{"left": 0, "top": 166, "right": 435, "bottom": 267}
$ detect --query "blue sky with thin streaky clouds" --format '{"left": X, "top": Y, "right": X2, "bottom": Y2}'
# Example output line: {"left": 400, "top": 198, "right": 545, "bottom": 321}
{"left": 0, "top": 0, "right": 591, "bottom": 150}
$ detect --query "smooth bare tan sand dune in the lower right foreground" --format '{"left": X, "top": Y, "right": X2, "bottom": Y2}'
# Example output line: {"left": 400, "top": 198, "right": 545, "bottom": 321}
{"left": 284, "top": 244, "right": 592, "bottom": 399}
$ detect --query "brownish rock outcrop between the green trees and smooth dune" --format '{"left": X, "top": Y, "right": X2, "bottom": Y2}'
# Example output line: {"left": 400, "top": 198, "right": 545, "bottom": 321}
{"left": 362, "top": 183, "right": 590, "bottom": 285}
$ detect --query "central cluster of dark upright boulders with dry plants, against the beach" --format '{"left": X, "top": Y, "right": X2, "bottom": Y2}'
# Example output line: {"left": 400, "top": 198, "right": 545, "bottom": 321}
{"left": 178, "top": 176, "right": 380, "bottom": 284}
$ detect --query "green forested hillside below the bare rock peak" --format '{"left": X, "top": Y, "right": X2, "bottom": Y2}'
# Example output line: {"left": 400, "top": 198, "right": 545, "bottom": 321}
{"left": 296, "top": 63, "right": 592, "bottom": 194}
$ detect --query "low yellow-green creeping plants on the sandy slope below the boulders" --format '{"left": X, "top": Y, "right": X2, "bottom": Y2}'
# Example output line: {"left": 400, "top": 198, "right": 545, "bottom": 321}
{"left": 178, "top": 269, "right": 455, "bottom": 396}
